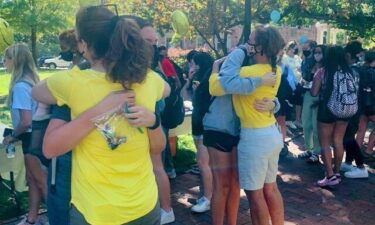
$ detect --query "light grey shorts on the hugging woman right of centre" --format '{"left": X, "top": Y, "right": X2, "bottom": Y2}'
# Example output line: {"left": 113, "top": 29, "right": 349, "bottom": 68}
{"left": 238, "top": 125, "right": 283, "bottom": 191}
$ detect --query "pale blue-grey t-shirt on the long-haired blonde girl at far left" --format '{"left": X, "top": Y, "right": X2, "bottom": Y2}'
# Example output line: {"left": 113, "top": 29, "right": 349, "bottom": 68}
{"left": 10, "top": 81, "right": 38, "bottom": 132}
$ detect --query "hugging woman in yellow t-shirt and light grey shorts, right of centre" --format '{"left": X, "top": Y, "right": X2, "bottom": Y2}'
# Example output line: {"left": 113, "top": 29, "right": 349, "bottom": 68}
{"left": 221, "top": 26, "right": 285, "bottom": 225}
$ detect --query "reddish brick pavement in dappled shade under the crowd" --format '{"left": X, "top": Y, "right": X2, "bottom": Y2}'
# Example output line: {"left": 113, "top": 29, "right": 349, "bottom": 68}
{"left": 171, "top": 135, "right": 375, "bottom": 225}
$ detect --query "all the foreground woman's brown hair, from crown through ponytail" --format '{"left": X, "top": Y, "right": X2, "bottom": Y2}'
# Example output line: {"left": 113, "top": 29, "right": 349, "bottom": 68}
{"left": 76, "top": 6, "right": 153, "bottom": 89}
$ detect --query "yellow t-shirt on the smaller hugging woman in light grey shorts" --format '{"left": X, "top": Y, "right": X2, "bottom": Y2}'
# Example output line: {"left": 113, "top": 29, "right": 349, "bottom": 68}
{"left": 233, "top": 64, "right": 281, "bottom": 128}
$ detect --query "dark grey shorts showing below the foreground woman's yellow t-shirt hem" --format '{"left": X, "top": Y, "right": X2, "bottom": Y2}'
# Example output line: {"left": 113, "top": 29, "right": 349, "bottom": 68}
{"left": 70, "top": 202, "right": 160, "bottom": 225}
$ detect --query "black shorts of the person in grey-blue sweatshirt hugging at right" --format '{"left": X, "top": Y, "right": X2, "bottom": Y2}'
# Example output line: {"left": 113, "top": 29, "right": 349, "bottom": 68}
{"left": 203, "top": 130, "right": 240, "bottom": 152}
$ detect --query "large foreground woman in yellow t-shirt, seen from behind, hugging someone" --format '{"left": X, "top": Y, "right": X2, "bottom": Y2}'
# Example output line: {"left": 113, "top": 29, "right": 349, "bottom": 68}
{"left": 36, "top": 7, "right": 169, "bottom": 225}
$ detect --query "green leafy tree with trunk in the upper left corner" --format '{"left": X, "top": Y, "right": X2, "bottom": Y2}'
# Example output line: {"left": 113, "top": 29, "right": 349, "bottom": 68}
{"left": 0, "top": 0, "right": 78, "bottom": 60}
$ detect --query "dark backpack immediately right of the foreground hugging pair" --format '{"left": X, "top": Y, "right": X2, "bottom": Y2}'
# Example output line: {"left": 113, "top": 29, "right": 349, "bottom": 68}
{"left": 161, "top": 79, "right": 185, "bottom": 129}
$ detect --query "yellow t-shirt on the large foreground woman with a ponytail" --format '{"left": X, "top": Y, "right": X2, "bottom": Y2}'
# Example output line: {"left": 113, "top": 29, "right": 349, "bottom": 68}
{"left": 47, "top": 68, "right": 164, "bottom": 225}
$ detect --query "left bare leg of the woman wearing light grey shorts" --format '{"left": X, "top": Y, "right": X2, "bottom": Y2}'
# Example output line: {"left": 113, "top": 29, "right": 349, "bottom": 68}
{"left": 245, "top": 189, "right": 269, "bottom": 225}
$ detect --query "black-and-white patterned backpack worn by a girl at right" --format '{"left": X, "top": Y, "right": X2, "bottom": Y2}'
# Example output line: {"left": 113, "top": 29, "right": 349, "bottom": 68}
{"left": 327, "top": 70, "right": 358, "bottom": 118}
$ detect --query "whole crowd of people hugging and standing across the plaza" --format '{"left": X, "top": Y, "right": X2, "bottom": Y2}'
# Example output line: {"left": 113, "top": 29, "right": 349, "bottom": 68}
{"left": 3, "top": 3, "right": 375, "bottom": 225}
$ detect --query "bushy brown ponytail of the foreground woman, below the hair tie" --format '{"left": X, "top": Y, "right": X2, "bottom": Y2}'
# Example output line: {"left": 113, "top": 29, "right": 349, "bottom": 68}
{"left": 104, "top": 17, "right": 153, "bottom": 88}
